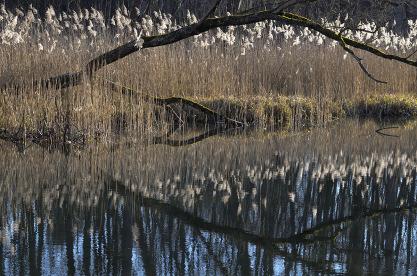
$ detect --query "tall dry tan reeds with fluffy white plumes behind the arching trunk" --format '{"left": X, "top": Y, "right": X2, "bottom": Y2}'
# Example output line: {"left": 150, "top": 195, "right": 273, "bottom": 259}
{"left": 0, "top": 7, "right": 417, "bottom": 140}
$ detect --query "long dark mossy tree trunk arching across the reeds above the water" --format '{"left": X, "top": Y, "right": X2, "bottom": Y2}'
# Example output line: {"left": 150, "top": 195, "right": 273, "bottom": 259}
{"left": 0, "top": 3, "right": 417, "bottom": 90}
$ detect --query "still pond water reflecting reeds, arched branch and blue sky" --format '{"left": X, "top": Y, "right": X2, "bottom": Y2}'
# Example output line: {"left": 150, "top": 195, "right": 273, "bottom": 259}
{"left": 0, "top": 121, "right": 417, "bottom": 275}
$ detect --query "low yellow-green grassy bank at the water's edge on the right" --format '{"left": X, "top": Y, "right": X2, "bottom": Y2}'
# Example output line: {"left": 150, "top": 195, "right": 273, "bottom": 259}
{"left": 201, "top": 94, "right": 417, "bottom": 129}
